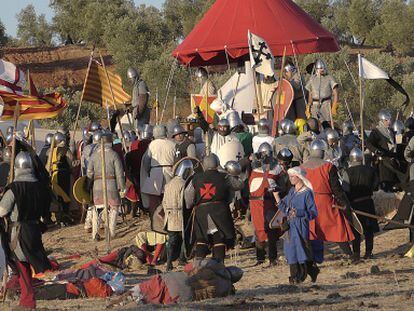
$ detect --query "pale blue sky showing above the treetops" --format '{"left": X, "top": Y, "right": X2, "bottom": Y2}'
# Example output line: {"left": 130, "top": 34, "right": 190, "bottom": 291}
{"left": 0, "top": 0, "right": 164, "bottom": 37}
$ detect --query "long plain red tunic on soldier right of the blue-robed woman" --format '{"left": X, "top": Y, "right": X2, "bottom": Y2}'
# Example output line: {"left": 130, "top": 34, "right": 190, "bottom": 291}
{"left": 305, "top": 162, "right": 355, "bottom": 242}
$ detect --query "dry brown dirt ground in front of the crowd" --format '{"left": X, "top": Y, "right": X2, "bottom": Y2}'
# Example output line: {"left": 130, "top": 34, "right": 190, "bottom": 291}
{"left": 0, "top": 214, "right": 414, "bottom": 310}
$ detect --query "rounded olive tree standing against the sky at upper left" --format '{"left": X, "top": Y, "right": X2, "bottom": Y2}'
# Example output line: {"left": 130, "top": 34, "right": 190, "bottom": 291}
{"left": 17, "top": 4, "right": 53, "bottom": 46}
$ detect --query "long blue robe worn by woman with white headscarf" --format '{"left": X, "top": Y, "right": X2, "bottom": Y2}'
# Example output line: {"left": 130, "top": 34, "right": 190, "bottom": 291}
{"left": 278, "top": 187, "right": 318, "bottom": 265}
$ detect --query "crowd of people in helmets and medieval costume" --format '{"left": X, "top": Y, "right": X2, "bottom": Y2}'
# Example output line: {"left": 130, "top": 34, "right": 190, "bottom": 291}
{"left": 0, "top": 60, "right": 414, "bottom": 307}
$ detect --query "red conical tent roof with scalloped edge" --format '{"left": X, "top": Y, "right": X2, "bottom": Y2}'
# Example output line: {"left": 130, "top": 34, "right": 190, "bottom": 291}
{"left": 173, "top": 0, "right": 340, "bottom": 66}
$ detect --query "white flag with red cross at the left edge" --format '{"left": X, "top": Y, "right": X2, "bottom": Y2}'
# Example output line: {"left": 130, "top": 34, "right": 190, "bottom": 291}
{"left": 0, "top": 59, "right": 26, "bottom": 95}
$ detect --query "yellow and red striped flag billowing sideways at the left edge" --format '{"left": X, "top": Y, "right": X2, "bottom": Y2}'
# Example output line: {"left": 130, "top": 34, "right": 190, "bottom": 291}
{"left": 0, "top": 91, "right": 67, "bottom": 121}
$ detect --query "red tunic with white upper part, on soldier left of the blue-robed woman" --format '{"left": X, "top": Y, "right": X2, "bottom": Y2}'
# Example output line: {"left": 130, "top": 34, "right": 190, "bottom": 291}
{"left": 249, "top": 166, "right": 282, "bottom": 242}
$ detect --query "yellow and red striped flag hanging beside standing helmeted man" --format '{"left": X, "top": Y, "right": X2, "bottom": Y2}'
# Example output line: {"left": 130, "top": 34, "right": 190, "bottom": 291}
{"left": 83, "top": 60, "right": 131, "bottom": 108}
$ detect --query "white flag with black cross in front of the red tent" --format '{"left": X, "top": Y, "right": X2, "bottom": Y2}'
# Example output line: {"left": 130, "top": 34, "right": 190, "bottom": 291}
{"left": 248, "top": 30, "right": 275, "bottom": 76}
